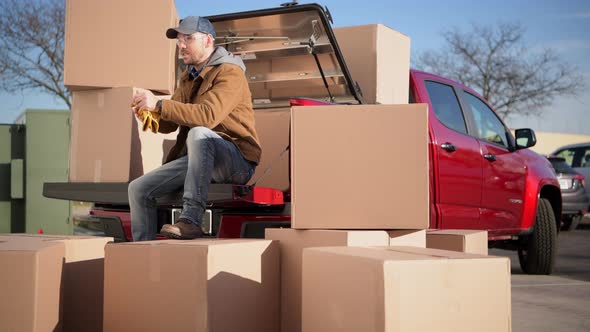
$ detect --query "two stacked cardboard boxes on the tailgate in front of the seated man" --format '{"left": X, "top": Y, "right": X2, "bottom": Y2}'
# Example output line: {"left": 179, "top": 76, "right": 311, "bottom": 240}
{"left": 64, "top": 0, "right": 178, "bottom": 182}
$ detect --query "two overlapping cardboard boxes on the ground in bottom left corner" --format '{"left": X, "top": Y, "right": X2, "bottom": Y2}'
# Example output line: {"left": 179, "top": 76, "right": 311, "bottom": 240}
{"left": 0, "top": 234, "right": 113, "bottom": 332}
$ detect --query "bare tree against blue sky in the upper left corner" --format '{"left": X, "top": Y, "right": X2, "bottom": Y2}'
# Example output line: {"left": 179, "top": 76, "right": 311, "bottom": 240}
{"left": 0, "top": 0, "right": 71, "bottom": 107}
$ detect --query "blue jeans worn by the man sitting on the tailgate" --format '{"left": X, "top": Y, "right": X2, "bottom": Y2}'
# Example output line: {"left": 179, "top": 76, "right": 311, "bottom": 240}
{"left": 129, "top": 127, "right": 256, "bottom": 241}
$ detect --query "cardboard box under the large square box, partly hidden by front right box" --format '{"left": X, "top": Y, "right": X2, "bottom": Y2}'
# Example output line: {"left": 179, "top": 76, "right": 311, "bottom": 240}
{"left": 265, "top": 228, "right": 389, "bottom": 332}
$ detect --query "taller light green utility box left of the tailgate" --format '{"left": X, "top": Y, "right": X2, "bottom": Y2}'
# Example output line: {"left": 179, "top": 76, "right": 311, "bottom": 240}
{"left": 25, "top": 110, "right": 73, "bottom": 234}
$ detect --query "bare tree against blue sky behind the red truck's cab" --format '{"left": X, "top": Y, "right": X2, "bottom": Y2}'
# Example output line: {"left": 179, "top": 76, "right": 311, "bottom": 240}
{"left": 414, "top": 24, "right": 584, "bottom": 118}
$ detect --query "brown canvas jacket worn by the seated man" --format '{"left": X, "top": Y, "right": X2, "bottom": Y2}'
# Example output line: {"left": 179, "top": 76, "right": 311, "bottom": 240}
{"left": 160, "top": 54, "right": 261, "bottom": 164}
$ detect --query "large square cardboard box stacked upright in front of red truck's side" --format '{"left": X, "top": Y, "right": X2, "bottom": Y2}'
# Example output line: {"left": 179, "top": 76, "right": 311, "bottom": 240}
{"left": 291, "top": 104, "right": 430, "bottom": 229}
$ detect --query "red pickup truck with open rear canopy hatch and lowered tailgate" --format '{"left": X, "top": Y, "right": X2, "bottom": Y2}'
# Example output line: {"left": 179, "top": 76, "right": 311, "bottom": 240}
{"left": 44, "top": 4, "right": 561, "bottom": 274}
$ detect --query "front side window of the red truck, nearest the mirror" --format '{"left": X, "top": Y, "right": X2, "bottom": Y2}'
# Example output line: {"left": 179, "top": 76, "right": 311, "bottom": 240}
{"left": 464, "top": 92, "right": 509, "bottom": 148}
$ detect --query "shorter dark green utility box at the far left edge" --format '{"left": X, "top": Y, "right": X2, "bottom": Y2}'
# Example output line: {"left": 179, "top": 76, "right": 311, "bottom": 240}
{"left": 0, "top": 124, "right": 26, "bottom": 233}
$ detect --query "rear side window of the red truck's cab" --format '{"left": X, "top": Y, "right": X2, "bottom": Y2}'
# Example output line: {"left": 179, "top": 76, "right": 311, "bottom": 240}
{"left": 424, "top": 81, "right": 467, "bottom": 134}
